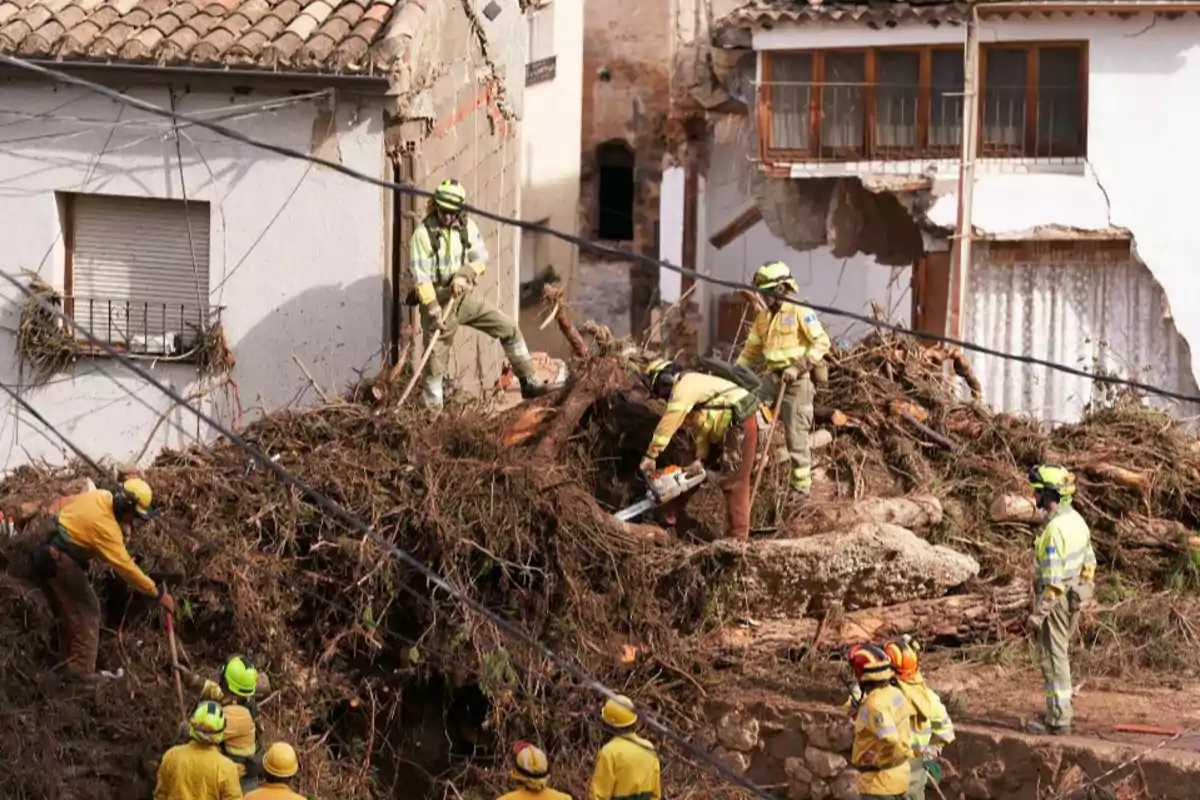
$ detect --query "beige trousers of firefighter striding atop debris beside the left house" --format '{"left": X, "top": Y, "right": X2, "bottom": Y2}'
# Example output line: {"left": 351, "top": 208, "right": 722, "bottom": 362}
{"left": 421, "top": 288, "right": 536, "bottom": 409}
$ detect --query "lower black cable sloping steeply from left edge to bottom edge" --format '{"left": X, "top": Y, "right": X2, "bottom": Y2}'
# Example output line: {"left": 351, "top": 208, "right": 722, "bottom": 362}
{"left": 0, "top": 266, "right": 778, "bottom": 800}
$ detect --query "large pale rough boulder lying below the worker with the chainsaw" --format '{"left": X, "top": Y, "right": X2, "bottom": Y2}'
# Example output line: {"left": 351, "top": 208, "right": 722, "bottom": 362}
{"left": 697, "top": 522, "right": 979, "bottom": 618}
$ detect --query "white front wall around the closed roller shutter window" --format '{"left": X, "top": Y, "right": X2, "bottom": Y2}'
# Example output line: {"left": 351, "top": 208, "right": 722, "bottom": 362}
{"left": 0, "top": 84, "right": 388, "bottom": 469}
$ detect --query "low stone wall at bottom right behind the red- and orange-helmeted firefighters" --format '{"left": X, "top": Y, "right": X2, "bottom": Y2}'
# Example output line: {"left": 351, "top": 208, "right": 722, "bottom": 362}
{"left": 700, "top": 700, "right": 1200, "bottom": 800}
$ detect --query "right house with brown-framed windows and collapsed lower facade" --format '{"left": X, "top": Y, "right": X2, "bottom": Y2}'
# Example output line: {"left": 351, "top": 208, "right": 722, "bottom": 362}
{"left": 661, "top": 0, "right": 1200, "bottom": 420}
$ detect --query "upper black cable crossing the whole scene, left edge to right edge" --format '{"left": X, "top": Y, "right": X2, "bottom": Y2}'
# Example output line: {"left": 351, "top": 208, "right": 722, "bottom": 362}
{"left": 0, "top": 54, "right": 1200, "bottom": 403}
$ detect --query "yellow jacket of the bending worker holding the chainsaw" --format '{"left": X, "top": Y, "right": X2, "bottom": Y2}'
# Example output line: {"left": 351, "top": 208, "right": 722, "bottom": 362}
{"left": 646, "top": 372, "right": 758, "bottom": 458}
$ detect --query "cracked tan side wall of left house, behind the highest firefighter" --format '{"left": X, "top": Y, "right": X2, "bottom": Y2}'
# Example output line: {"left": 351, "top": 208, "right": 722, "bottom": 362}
{"left": 389, "top": 0, "right": 526, "bottom": 392}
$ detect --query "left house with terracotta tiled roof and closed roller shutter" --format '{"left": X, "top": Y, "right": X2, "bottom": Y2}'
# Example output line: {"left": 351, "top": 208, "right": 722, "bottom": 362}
{"left": 0, "top": 0, "right": 528, "bottom": 468}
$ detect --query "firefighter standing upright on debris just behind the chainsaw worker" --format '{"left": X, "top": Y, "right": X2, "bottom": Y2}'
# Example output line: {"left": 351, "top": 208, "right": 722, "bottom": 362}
{"left": 738, "top": 261, "right": 830, "bottom": 497}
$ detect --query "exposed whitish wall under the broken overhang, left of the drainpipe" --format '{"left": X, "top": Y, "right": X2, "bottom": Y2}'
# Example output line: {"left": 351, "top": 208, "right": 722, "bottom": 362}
{"left": 700, "top": 138, "right": 912, "bottom": 342}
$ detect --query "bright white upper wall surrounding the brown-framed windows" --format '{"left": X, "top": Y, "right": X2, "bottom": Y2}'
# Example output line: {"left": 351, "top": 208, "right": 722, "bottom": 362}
{"left": 754, "top": 14, "right": 1200, "bottom": 400}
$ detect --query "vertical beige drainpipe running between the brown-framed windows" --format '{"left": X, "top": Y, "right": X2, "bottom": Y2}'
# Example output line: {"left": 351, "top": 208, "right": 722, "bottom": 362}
{"left": 946, "top": 6, "right": 980, "bottom": 338}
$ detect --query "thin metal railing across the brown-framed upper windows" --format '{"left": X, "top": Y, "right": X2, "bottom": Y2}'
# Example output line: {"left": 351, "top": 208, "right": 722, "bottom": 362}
{"left": 760, "top": 83, "right": 1085, "bottom": 162}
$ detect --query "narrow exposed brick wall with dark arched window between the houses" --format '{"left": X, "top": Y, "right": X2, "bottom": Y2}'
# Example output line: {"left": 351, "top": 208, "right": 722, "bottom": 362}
{"left": 572, "top": 0, "right": 673, "bottom": 335}
